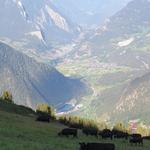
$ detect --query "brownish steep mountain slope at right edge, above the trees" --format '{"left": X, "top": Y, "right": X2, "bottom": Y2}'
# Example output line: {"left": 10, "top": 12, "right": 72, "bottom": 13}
{"left": 113, "top": 73, "right": 150, "bottom": 122}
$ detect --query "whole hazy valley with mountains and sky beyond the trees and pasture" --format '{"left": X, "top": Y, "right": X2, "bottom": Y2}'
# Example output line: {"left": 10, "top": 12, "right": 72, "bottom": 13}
{"left": 0, "top": 0, "right": 150, "bottom": 123}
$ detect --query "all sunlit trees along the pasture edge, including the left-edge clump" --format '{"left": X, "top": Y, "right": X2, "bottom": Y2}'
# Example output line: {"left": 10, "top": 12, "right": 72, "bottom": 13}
{"left": 0, "top": 91, "right": 150, "bottom": 136}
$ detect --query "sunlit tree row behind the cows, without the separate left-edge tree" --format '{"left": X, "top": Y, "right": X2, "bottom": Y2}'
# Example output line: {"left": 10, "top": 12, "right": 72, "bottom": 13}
{"left": 37, "top": 104, "right": 150, "bottom": 136}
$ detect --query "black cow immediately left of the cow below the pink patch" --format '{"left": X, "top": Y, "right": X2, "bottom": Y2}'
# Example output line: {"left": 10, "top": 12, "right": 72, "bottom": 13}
{"left": 112, "top": 129, "right": 128, "bottom": 140}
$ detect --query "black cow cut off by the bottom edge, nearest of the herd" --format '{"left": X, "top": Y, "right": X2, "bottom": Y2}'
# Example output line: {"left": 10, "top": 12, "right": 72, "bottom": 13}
{"left": 79, "top": 143, "right": 115, "bottom": 150}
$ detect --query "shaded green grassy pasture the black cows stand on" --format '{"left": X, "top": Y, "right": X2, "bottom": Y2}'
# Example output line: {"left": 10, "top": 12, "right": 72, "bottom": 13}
{"left": 0, "top": 101, "right": 150, "bottom": 150}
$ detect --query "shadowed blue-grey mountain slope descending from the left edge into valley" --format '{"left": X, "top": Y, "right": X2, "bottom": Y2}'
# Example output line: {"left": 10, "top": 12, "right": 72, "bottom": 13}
{"left": 0, "top": 43, "right": 85, "bottom": 108}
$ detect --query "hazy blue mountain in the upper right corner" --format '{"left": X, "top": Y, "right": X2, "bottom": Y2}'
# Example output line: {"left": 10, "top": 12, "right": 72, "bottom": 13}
{"left": 95, "top": 0, "right": 150, "bottom": 38}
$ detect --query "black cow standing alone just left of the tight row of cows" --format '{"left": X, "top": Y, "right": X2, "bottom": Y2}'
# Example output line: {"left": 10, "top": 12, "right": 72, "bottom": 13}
{"left": 58, "top": 128, "right": 78, "bottom": 137}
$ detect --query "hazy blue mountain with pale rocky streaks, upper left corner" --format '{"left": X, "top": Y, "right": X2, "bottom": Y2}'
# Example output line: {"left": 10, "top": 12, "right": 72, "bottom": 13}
{"left": 0, "top": 0, "right": 78, "bottom": 55}
